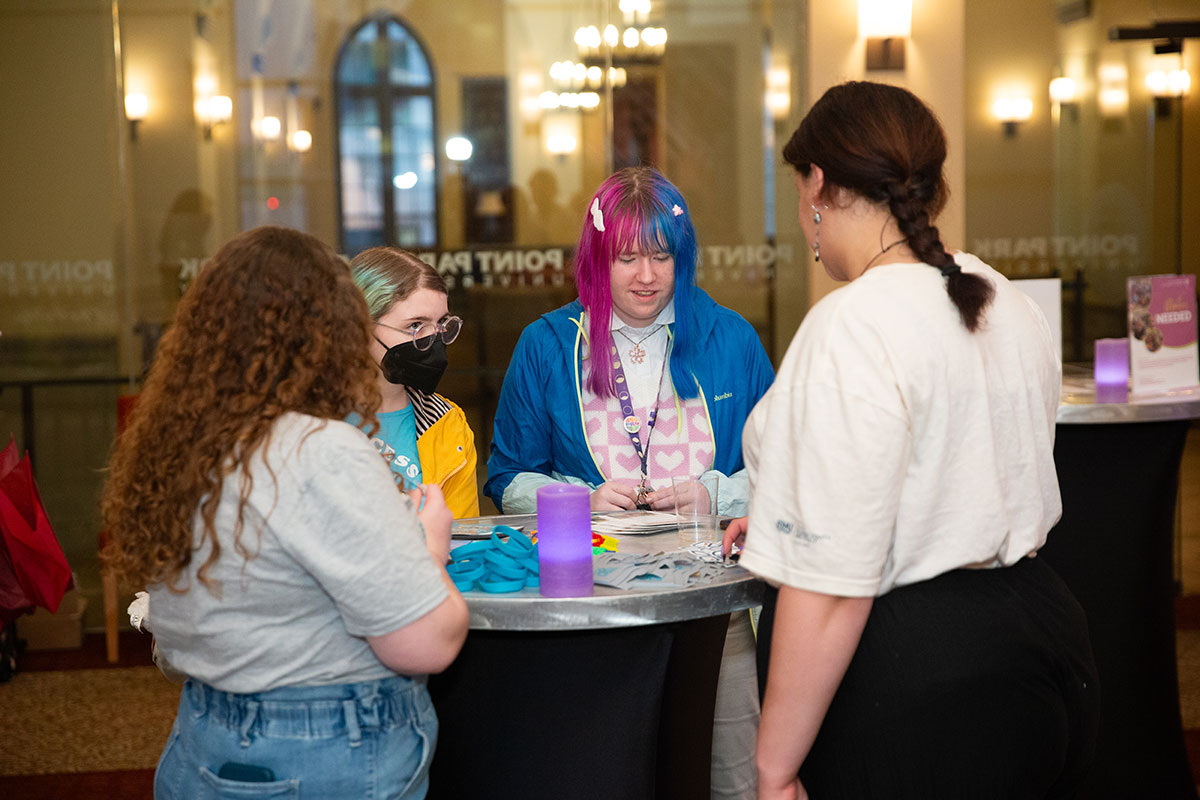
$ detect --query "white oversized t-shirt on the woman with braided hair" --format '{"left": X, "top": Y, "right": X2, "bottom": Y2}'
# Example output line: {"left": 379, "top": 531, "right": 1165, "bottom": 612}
{"left": 740, "top": 254, "right": 1062, "bottom": 597}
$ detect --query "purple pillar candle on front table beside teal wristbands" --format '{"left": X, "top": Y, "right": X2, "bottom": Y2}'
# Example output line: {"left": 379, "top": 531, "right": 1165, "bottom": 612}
{"left": 538, "top": 483, "right": 593, "bottom": 597}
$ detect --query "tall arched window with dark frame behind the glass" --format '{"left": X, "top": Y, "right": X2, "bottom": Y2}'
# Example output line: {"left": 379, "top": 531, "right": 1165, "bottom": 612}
{"left": 334, "top": 16, "right": 438, "bottom": 255}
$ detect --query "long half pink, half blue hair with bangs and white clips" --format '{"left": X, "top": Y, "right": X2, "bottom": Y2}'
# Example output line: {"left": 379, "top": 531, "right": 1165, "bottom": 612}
{"left": 575, "top": 167, "right": 700, "bottom": 399}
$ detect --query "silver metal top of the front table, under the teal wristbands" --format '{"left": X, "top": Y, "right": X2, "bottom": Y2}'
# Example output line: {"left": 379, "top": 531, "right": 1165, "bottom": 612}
{"left": 455, "top": 515, "right": 763, "bottom": 631}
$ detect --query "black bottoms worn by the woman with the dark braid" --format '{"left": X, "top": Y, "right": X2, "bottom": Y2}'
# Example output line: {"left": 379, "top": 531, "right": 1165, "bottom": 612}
{"left": 758, "top": 559, "right": 1099, "bottom": 800}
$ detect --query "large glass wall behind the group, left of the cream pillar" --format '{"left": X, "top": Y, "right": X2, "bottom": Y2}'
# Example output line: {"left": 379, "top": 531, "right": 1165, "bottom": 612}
{"left": 0, "top": 0, "right": 808, "bottom": 624}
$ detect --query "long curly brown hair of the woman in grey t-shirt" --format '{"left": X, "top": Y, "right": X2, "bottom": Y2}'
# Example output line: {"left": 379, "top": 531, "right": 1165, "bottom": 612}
{"left": 101, "top": 227, "right": 380, "bottom": 591}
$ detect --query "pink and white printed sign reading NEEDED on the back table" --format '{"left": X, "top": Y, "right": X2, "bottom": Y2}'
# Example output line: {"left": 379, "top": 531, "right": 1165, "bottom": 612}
{"left": 1126, "top": 275, "right": 1200, "bottom": 395}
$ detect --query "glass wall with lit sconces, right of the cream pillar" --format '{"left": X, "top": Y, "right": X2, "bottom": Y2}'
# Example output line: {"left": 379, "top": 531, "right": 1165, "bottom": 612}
{"left": 965, "top": 0, "right": 1200, "bottom": 361}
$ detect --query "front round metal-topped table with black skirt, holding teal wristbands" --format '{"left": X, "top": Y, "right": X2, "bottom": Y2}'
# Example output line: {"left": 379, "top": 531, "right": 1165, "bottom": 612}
{"left": 428, "top": 515, "right": 762, "bottom": 800}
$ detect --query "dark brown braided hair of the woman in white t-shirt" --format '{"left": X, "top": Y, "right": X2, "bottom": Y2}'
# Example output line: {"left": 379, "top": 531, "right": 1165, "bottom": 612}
{"left": 784, "top": 80, "right": 995, "bottom": 332}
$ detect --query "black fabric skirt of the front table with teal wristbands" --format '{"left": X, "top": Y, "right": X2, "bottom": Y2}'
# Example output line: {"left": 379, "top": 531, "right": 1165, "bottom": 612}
{"left": 428, "top": 615, "right": 728, "bottom": 800}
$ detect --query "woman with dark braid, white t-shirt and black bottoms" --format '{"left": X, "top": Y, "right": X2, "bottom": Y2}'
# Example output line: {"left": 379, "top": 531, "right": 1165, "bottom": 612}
{"left": 726, "top": 83, "right": 1098, "bottom": 800}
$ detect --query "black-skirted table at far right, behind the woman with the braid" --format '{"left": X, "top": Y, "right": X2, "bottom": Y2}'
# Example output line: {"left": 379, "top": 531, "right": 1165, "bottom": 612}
{"left": 1040, "top": 365, "right": 1200, "bottom": 800}
